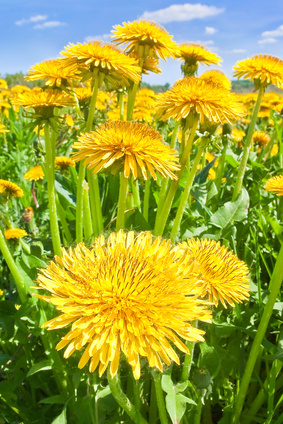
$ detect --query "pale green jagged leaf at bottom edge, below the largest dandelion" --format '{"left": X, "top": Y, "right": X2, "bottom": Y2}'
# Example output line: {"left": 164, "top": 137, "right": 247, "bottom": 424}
{"left": 161, "top": 375, "right": 196, "bottom": 424}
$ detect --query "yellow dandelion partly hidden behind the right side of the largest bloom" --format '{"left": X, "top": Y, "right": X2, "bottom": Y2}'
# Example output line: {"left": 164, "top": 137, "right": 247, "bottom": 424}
{"left": 176, "top": 238, "right": 249, "bottom": 308}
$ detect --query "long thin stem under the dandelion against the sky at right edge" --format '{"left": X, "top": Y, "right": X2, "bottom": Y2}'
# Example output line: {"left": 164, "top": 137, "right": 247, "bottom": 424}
{"left": 232, "top": 85, "right": 264, "bottom": 202}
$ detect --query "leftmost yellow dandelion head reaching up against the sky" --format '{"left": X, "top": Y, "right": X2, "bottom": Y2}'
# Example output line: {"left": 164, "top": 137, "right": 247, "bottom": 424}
{"left": 25, "top": 59, "right": 78, "bottom": 87}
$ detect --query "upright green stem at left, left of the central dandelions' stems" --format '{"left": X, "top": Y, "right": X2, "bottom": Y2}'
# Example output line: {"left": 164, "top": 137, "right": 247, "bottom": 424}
{"left": 44, "top": 123, "right": 61, "bottom": 256}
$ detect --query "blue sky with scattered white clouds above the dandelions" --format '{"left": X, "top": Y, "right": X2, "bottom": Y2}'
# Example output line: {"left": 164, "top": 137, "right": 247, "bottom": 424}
{"left": 0, "top": 0, "right": 283, "bottom": 84}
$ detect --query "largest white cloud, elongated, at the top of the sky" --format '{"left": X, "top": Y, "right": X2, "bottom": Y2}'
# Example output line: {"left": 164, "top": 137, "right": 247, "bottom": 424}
{"left": 139, "top": 3, "right": 225, "bottom": 24}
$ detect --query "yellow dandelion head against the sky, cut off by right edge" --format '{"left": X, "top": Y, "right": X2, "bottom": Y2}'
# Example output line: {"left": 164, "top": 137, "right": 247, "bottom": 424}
{"left": 234, "top": 54, "right": 283, "bottom": 88}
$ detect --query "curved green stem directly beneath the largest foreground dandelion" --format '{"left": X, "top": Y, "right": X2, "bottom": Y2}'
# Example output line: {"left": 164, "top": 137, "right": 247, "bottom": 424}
{"left": 107, "top": 367, "right": 148, "bottom": 424}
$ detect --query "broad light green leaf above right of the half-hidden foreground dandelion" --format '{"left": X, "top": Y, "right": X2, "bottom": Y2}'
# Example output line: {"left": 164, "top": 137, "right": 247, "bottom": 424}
{"left": 210, "top": 189, "right": 249, "bottom": 229}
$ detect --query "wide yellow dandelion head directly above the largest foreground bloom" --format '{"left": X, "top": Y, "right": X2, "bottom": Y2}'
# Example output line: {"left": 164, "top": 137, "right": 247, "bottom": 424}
{"left": 73, "top": 121, "right": 179, "bottom": 180}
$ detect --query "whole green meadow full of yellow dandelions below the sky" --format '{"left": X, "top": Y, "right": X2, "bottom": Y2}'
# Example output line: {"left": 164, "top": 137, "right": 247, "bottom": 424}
{"left": 0, "top": 21, "right": 283, "bottom": 424}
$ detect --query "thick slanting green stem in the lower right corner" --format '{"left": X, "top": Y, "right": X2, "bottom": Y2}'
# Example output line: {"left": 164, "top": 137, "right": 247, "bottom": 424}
{"left": 233, "top": 244, "right": 283, "bottom": 424}
